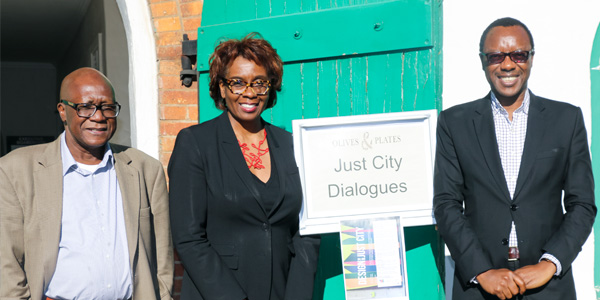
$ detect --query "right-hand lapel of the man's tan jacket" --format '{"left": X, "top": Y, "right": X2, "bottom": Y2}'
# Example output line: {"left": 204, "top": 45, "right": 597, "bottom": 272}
{"left": 111, "top": 149, "right": 140, "bottom": 270}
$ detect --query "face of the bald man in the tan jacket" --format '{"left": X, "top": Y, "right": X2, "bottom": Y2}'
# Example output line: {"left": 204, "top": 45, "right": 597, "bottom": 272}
{"left": 58, "top": 69, "right": 117, "bottom": 162}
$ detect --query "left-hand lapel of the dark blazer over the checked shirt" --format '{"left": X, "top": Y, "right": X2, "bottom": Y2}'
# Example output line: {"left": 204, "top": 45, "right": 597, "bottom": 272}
{"left": 473, "top": 94, "right": 510, "bottom": 201}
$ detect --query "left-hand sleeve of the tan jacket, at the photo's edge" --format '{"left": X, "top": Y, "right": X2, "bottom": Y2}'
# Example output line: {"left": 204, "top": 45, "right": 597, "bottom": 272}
{"left": 0, "top": 166, "right": 31, "bottom": 300}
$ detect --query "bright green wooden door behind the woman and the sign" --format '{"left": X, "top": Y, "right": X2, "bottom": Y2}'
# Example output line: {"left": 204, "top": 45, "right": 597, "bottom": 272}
{"left": 197, "top": 0, "right": 445, "bottom": 300}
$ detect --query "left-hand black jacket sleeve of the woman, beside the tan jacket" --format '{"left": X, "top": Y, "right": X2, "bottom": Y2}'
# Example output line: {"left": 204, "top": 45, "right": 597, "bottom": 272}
{"left": 168, "top": 129, "right": 246, "bottom": 300}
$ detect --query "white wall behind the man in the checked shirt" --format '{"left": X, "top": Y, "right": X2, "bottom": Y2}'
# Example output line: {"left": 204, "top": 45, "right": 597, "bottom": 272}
{"left": 443, "top": 0, "right": 600, "bottom": 299}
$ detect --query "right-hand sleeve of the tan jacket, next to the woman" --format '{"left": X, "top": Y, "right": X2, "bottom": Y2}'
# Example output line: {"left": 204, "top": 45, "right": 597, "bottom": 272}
{"left": 150, "top": 162, "right": 174, "bottom": 300}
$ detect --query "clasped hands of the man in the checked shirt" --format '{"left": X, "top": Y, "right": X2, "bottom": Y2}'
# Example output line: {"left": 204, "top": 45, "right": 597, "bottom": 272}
{"left": 476, "top": 260, "right": 556, "bottom": 299}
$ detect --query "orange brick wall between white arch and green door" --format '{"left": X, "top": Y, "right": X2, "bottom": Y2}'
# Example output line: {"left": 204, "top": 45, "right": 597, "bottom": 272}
{"left": 148, "top": 0, "right": 203, "bottom": 300}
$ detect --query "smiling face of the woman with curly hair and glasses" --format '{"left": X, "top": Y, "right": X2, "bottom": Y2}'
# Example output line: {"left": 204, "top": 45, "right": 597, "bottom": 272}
{"left": 220, "top": 56, "right": 269, "bottom": 127}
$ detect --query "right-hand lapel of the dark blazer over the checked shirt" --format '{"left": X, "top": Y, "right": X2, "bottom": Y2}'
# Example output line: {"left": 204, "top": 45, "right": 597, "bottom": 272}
{"left": 514, "top": 92, "right": 547, "bottom": 199}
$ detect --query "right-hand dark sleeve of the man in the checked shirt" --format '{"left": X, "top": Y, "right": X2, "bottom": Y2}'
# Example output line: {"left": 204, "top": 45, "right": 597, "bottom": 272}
{"left": 543, "top": 108, "right": 597, "bottom": 275}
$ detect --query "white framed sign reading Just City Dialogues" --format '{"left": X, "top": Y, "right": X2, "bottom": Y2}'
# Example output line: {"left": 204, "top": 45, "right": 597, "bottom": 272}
{"left": 292, "top": 110, "right": 437, "bottom": 234}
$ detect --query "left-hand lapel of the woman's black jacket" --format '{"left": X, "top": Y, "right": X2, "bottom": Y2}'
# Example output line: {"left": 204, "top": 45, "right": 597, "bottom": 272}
{"left": 217, "top": 110, "right": 267, "bottom": 215}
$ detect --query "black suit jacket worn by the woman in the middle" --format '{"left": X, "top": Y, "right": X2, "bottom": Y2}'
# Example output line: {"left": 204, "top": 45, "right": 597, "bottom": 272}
{"left": 169, "top": 111, "right": 319, "bottom": 300}
